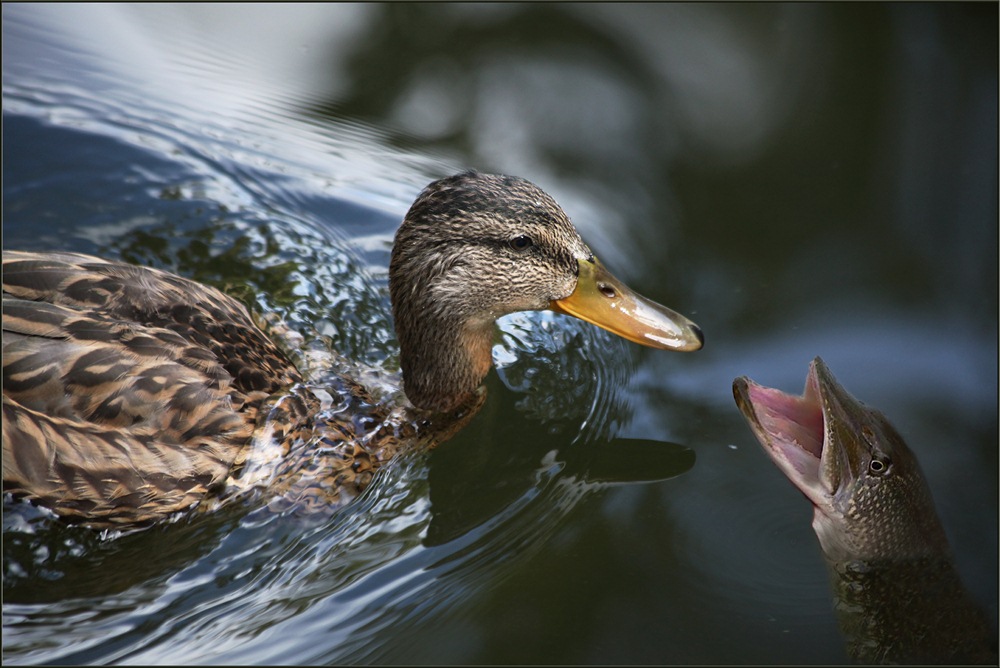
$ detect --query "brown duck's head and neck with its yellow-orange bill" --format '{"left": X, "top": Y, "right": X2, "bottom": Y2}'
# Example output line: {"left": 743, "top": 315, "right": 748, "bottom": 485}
{"left": 389, "top": 172, "right": 704, "bottom": 412}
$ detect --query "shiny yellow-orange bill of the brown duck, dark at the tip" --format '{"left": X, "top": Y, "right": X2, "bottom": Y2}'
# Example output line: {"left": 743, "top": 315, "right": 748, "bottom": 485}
{"left": 549, "top": 258, "right": 705, "bottom": 351}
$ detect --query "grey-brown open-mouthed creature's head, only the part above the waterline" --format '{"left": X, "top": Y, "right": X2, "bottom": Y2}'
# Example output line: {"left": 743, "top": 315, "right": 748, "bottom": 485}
{"left": 733, "top": 357, "right": 947, "bottom": 561}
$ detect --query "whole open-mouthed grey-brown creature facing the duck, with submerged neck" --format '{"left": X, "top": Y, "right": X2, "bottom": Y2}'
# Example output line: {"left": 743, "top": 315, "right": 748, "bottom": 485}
{"left": 733, "top": 357, "right": 997, "bottom": 665}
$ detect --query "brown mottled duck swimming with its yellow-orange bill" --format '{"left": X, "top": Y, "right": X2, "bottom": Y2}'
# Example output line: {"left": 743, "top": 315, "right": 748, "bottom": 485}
{"left": 2, "top": 171, "right": 704, "bottom": 530}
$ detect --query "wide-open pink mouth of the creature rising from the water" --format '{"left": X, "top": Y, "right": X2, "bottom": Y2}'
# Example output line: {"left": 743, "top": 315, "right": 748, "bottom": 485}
{"left": 733, "top": 358, "right": 834, "bottom": 506}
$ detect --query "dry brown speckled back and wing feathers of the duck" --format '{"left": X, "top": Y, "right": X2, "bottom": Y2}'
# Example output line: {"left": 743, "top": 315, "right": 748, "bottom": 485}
{"left": 3, "top": 251, "right": 299, "bottom": 526}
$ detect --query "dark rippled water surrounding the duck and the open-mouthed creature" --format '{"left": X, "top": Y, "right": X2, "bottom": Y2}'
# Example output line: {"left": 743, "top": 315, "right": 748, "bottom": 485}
{"left": 3, "top": 4, "right": 998, "bottom": 663}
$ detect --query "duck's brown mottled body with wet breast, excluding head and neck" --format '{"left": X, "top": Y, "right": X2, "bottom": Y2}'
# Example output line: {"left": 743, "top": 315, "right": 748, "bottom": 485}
{"left": 3, "top": 251, "right": 485, "bottom": 528}
